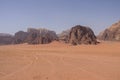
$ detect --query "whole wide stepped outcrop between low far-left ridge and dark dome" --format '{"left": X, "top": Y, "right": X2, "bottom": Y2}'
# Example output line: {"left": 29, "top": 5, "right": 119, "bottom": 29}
{"left": 13, "top": 28, "right": 57, "bottom": 44}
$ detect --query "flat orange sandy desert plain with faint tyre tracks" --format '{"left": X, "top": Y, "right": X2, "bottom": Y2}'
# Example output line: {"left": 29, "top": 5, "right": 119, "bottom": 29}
{"left": 0, "top": 42, "right": 120, "bottom": 80}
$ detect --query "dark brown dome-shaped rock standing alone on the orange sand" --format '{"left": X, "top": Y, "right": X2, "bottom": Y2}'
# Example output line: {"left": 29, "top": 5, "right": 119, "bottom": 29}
{"left": 69, "top": 25, "right": 97, "bottom": 45}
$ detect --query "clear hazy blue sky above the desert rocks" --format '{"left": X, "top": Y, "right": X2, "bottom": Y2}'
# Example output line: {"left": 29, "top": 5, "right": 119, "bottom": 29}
{"left": 0, "top": 0, "right": 120, "bottom": 34}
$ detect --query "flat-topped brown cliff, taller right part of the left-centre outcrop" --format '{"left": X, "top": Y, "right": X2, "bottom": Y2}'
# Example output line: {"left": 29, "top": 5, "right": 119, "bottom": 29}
{"left": 27, "top": 28, "right": 57, "bottom": 44}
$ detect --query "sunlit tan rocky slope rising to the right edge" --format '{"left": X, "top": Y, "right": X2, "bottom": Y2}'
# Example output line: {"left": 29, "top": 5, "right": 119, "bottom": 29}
{"left": 98, "top": 21, "right": 120, "bottom": 41}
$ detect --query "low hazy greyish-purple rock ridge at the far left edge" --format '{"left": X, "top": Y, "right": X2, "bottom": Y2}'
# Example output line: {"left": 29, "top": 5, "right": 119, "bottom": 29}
{"left": 0, "top": 33, "right": 13, "bottom": 45}
